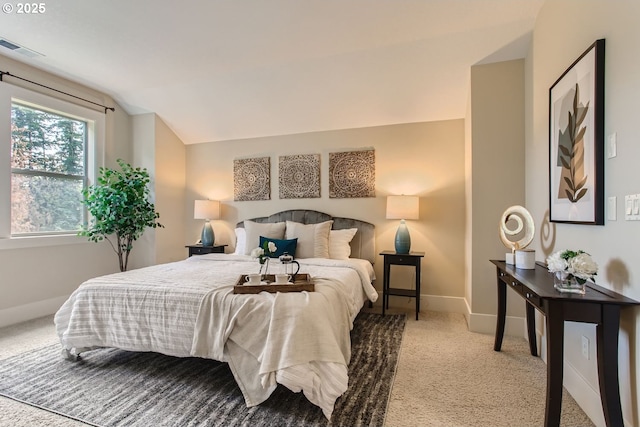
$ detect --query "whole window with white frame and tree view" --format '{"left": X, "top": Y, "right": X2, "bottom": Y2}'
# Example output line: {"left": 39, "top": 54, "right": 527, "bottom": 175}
{"left": 0, "top": 84, "right": 104, "bottom": 248}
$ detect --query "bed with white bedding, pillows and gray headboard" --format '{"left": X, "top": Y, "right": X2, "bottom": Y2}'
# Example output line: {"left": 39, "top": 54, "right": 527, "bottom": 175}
{"left": 55, "top": 210, "right": 378, "bottom": 419}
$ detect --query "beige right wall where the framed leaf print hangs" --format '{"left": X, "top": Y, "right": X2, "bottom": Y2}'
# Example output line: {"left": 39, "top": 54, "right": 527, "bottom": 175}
{"left": 526, "top": 0, "right": 640, "bottom": 426}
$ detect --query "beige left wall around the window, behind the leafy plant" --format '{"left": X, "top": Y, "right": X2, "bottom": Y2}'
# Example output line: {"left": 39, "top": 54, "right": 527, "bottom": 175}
{"left": 0, "top": 56, "right": 131, "bottom": 325}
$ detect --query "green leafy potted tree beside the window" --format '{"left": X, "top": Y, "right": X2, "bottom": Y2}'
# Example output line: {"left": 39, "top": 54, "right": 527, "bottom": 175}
{"left": 78, "top": 159, "right": 164, "bottom": 271}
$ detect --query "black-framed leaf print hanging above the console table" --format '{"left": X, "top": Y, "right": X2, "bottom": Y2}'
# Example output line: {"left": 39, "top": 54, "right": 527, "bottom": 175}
{"left": 549, "top": 39, "right": 605, "bottom": 225}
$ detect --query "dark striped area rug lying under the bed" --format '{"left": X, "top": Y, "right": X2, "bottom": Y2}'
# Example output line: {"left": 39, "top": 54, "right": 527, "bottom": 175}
{"left": 0, "top": 313, "right": 405, "bottom": 427}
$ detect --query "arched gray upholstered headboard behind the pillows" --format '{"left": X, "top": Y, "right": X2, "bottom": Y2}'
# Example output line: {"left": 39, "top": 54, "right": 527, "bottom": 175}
{"left": 237, "top": 209, "right": 376, "bottom": 264}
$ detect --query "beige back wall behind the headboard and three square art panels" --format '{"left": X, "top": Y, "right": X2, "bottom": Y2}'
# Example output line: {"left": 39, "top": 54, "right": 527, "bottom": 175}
{"left": 185, "top": 120, "right": 465, "bottom": 307}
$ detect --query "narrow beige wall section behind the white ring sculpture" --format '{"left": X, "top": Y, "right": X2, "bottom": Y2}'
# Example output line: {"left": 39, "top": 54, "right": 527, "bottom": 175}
{"left": 466, "top": 60, "right": 524, "bottom": 333}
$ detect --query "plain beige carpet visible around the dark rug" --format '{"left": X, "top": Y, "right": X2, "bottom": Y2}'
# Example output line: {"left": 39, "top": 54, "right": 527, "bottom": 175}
{"left": 0, "top": 312, "right": 593, "bottom": 427}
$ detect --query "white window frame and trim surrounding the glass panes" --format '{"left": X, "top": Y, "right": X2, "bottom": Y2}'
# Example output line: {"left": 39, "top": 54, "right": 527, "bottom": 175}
{"left": 0, "top": 82, "right": 105, "bottom": 249}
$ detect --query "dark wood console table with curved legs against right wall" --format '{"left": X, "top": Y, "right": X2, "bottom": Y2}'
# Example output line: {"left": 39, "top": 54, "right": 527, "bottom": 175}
{"left": 491, "top": 260, "right": 640, "bottom": 427}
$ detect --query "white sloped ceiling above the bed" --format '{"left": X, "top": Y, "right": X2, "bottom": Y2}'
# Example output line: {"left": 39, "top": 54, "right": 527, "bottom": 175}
{"left": 0, "top": 0, "right": 543, "bottom": 144}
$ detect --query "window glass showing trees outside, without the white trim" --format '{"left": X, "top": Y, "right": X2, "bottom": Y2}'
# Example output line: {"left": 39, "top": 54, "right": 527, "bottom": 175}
{"left": 11, "top": 102, "right": 88, "bottom": 234}
